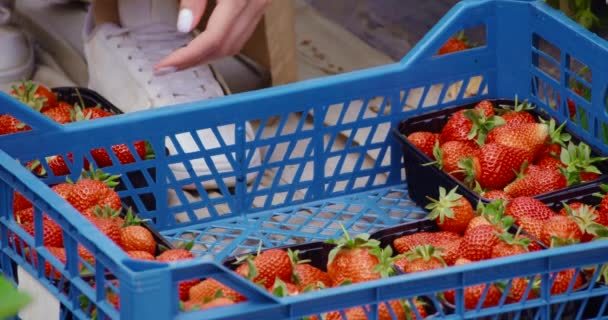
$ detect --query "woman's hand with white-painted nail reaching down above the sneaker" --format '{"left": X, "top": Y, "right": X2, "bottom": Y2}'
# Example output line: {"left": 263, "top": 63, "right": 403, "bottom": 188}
{"left": 156, "top": 0, "right": 271, "bottom": 71}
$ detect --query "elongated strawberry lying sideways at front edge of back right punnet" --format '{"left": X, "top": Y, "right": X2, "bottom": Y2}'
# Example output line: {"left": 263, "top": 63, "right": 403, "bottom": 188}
{"left": 504, "top": 165, "right": 567, "bottom": 198}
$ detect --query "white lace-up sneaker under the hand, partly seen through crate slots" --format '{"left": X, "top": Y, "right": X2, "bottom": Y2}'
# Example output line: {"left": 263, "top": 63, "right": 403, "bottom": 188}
{"left": 84, "top": 0, "right": 260, "bottom": 189}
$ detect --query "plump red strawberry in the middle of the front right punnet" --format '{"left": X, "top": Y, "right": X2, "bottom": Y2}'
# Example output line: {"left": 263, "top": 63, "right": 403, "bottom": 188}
{"left": 458, "top": 225, "right": 501, "bottom": 261}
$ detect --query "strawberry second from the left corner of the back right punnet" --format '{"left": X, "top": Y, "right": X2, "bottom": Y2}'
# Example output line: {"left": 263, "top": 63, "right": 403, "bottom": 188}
{"left": 429, "top": 140, "right": 476, "bottom": 180}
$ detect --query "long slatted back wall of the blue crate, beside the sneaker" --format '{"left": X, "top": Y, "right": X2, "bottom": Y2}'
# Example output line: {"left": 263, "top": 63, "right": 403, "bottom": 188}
{"left": 0, "top": 13, "right": 496, "bottom": 235}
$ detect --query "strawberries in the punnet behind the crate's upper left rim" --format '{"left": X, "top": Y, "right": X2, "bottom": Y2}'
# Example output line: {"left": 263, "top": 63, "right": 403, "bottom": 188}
{"left": 0, "top": 81, "right": 154, "bottom": 176}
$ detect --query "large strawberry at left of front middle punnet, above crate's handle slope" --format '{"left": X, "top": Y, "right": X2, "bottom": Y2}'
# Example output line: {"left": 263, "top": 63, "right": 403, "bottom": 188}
{"left": 236, "top": 249, "right": 293, "bottom": 288}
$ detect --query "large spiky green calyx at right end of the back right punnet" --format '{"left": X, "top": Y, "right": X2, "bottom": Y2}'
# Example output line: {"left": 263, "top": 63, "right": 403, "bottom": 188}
{"left": 560, "top": 142, "right": 608, "bottom": 186}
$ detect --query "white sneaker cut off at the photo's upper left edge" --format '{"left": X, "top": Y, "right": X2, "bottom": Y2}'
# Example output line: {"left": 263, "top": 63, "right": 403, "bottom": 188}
{"left": 0, "top": 6, "right": 34, "bottom": 87}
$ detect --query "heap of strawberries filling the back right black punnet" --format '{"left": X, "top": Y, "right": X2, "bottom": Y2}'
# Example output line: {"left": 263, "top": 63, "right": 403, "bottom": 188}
{"left": 407, "top": 100, "right": 607, "bottom": 199}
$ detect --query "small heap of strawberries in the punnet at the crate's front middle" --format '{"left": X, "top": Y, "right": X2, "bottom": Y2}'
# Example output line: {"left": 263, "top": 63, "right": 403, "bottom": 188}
{"left": 178, "top": 236, "right": 428, "bottom": 320}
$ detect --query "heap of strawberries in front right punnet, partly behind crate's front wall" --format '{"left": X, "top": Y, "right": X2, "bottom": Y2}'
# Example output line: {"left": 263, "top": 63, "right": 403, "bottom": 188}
{"left": 384, "top": 188, "right": 608, "bottom": 309}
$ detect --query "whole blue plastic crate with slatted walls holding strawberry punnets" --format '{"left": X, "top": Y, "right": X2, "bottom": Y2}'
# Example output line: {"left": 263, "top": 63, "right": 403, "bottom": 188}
{"left": 0, "top": 0, "right": 608, "bottom": 319}
